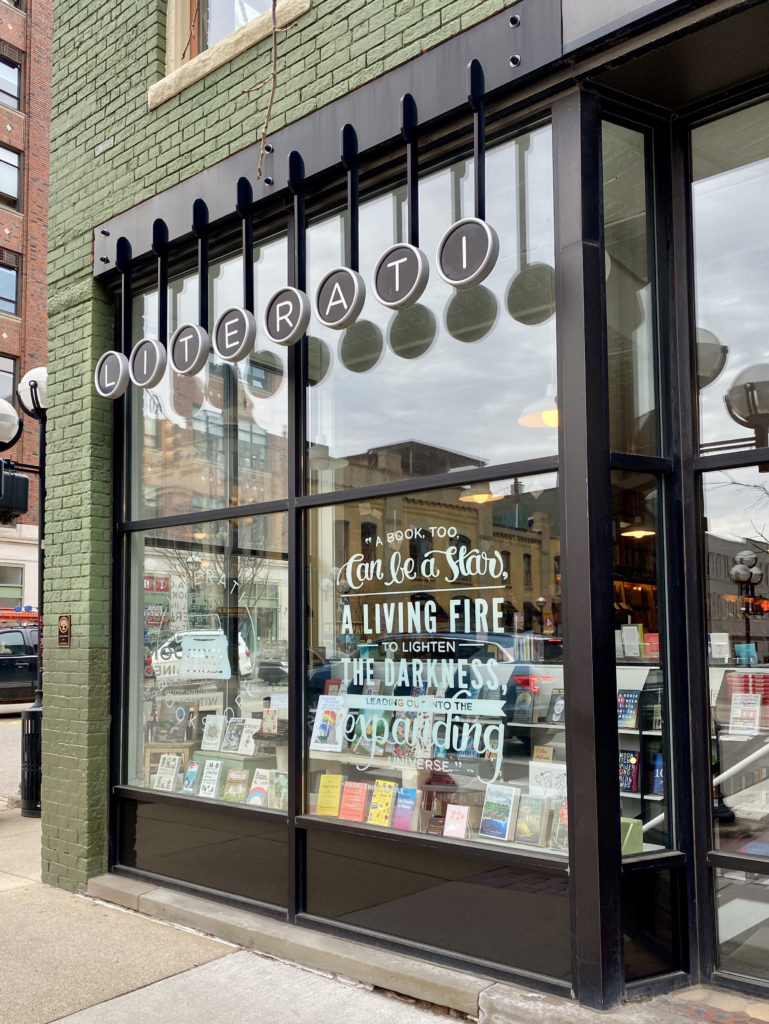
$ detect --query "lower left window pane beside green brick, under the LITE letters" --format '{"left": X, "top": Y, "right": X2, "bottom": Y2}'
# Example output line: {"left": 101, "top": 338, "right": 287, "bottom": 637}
{"left": 126, "top": 515, "right": 289, "bottom": 811}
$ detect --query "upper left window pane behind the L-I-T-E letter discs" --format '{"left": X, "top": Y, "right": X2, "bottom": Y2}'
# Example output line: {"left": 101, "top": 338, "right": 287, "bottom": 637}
{"left": 130, "top": 238, "right": 288, "bottom": 519}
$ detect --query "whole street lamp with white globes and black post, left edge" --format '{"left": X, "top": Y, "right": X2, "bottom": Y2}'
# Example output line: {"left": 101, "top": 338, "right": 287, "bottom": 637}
{"left": 0, "top": 367, "right": 48, "bottom": 818}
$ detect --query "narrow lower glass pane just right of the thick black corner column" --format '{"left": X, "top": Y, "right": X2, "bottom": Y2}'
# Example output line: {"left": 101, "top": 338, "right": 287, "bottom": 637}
{"left": 611, "top": 472, "right": 672, "bottom": 856}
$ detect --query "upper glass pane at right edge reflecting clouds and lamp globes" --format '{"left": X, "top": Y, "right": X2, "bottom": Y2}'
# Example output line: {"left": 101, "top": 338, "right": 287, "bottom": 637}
{"left": 691, "top": 102, "right": 769, "bottom": 454}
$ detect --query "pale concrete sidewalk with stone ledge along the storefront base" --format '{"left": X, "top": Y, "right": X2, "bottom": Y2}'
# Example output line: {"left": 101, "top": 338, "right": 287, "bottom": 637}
{"left": 0, "top": 799, "right": 769, "bottom": 1024}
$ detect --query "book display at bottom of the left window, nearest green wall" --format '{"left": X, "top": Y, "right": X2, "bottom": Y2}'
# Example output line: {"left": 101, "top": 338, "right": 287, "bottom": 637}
{"left": 144, "top": 710, "right": 288, "bottom": 811}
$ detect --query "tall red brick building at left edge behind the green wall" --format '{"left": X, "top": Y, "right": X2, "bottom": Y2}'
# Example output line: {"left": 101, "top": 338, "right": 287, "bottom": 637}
{"left": 0, "top": 0, "right": 53, "bottom": 608}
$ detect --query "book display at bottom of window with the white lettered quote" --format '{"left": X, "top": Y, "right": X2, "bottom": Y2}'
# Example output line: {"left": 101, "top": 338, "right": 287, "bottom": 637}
{"left": 308, "top": 691, "right": 568, "bottom": 858}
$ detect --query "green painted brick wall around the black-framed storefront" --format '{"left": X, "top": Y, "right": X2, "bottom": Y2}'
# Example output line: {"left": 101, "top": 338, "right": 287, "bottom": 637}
{"left": 43, "top": 0, "right": 506, "bottom": 890}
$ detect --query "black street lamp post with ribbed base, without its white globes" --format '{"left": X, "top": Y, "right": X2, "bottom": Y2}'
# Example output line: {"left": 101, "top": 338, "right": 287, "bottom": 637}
{"left": 22, "top": 397, "right": 46, "bottom": 818}
